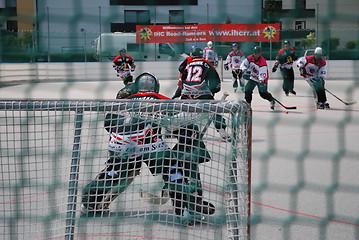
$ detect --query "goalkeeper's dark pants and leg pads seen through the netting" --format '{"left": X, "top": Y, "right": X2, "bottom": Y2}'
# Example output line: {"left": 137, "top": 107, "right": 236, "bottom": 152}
{"left": 82, "top": 142, "right": 207, "bottom": 215}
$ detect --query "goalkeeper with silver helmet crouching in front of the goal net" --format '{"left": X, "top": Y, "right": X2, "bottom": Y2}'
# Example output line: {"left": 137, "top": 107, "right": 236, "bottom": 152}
{"left": 81, "top": 73, "right": 215, "bottom": 225}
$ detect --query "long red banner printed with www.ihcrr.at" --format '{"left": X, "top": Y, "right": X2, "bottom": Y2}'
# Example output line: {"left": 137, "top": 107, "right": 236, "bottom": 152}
{"left": 136, "top": 24, "right": 280, "bottom": 43}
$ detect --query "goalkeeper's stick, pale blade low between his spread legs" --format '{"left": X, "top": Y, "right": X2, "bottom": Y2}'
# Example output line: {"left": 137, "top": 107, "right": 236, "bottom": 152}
{"left": 139, "top": 92, "right": 229, "bottom": 205}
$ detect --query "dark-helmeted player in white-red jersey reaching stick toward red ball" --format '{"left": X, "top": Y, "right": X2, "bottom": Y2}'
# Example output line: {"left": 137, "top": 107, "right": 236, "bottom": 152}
{"left": 240, "top": 46, "right": 275, "bottom": 110}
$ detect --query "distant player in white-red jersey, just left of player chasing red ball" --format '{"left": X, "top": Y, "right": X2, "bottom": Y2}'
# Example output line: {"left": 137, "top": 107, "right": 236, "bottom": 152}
{"left": 224, "top": 43, "right": 246, "bottom": 92}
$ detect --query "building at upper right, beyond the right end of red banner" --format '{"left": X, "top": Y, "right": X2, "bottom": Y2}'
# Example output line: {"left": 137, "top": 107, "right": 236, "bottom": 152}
{"left": 263, "top": 0, "right": 359, "bottom": 49}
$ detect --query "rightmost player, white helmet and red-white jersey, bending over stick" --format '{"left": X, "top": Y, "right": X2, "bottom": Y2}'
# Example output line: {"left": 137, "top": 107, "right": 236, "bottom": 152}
{"left": 297, "top": 47, "right": 330, "bottom": 109}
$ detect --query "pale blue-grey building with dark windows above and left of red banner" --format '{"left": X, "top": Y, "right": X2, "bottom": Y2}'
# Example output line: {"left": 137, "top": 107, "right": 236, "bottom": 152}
{"left": 35, "top": 0, "right": 262, "bottom": 53}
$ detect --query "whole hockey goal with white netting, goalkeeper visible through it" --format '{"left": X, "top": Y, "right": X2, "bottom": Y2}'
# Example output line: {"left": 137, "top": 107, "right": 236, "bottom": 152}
{"left": 0, "top": 99, "right": 252, "bottom": 239}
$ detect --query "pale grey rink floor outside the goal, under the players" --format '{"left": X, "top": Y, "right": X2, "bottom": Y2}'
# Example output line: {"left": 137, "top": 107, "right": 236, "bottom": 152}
{"left": 0, "top": 61, "right": 359, "bottom": 240}
